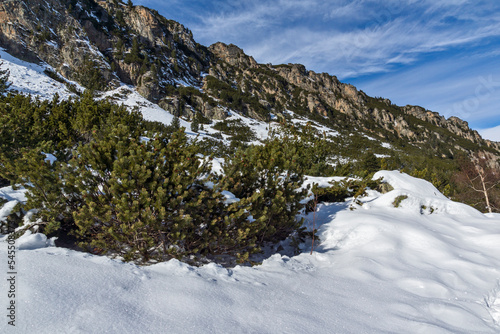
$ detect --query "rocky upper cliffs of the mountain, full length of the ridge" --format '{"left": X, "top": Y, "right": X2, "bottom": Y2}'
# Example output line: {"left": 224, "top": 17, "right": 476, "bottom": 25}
{"left": 0, "top": 0, "right": 500, "bottom": 156}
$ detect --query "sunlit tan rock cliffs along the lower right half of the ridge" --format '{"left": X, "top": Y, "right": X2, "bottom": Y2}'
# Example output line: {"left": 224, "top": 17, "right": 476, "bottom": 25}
{"left": 203, "top": 43, "right": 493, "bottom": 150}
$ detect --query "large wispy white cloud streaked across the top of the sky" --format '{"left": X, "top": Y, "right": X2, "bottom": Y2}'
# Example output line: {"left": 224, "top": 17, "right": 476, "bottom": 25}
{"left": 174, "top": 0, "right": 500, "bottom": 78}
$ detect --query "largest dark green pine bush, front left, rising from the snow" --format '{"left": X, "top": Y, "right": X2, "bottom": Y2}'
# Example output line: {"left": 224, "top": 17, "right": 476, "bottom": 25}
{"left": 65, "top": 125, "right": 250, "bottom": 262}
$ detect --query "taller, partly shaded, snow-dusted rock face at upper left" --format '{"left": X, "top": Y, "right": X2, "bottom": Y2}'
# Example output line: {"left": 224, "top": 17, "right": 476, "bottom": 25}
{"left": 0, "top": 0, "right": 208, "bottom": 95}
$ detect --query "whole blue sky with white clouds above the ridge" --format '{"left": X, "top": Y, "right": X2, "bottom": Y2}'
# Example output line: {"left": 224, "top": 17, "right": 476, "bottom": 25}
{"left": 133, "top": 0, "right": 500, "bottom": 141}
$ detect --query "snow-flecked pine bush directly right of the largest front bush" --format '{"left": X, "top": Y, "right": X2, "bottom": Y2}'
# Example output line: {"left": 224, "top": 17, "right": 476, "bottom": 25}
{"left": 221, "top": 133, "right": 307, "bottom": 246}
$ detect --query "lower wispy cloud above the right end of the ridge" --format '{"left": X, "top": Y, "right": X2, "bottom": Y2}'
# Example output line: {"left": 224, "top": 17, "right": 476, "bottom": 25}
{"left": 351, "top": 56, "right": 500, "bottom": 129}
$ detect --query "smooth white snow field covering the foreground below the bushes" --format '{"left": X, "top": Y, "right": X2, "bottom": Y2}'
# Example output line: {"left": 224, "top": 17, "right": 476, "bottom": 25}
{"left": 0, "top": 171, "right": 500, "bottom": 334}
